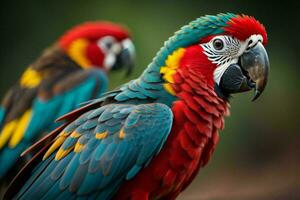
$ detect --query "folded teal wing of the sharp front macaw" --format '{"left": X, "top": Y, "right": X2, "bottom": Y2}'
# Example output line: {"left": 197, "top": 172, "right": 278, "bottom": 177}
{"left": 13, "top": 103, "right": 173, "bottom": 199}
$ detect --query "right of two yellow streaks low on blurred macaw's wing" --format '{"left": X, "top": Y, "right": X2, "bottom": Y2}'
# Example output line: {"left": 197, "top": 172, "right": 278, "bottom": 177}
{"left": 8, "top": 109, "right": 32, "bottom": 148}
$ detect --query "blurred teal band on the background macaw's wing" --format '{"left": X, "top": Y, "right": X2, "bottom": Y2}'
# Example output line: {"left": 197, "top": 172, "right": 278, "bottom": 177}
{"left": 24, "top": 69, "right": 108, "bottom": 144}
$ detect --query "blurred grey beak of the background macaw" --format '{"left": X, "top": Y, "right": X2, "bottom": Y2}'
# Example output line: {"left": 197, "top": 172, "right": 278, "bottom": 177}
{"left": 112, "top": 39, "right": 135, "bottom": 76}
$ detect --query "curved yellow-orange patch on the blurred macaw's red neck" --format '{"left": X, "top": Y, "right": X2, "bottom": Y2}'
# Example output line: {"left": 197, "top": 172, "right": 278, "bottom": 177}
{"left": 68, "top": 39, "right": 91, "bottom": 68}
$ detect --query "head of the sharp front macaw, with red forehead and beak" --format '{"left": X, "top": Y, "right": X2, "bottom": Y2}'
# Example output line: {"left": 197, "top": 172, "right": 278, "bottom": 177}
{"left": 161, "top": 13, "right": 269, "bottom": 100}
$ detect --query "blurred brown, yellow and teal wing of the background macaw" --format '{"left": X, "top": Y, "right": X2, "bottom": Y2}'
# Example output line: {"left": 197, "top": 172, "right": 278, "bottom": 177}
{"left": 0, "top": 69, "right": 107, "bottom": 178}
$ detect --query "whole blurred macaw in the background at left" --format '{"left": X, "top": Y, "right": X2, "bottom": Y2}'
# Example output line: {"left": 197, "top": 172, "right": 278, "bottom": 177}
{"left": 0, "top": 21, "right": 135, "bottom": 183}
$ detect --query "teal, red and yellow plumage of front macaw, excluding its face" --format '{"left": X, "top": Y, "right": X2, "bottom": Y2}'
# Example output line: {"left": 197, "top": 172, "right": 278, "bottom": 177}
{"left": 6, "top": 13, "right": 268, "bottom": 200}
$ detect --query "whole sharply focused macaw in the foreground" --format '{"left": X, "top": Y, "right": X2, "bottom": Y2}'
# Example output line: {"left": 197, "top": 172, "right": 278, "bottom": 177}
{"left": 6, "top": 13, "right": 269, "bottom": 200}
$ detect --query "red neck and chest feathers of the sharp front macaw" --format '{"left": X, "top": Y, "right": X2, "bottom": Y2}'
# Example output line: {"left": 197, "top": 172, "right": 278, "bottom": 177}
{"left": 163, "top": 67, "right": 229, "bottom": 193}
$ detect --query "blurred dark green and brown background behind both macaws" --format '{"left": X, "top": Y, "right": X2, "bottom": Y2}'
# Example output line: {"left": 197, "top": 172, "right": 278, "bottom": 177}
{"left": 0, "top": 0, "right": 300, "bottom": 200}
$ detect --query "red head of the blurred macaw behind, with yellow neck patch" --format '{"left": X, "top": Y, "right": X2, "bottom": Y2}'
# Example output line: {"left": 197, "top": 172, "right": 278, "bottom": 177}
{"left": 58, "top": 22, "right": 135, "bottom": 74}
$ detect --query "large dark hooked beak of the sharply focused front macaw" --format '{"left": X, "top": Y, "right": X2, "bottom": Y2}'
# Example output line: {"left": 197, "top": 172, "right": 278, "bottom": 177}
{"left": 219, "top": 42, "right": 270, "bottom": 101}
